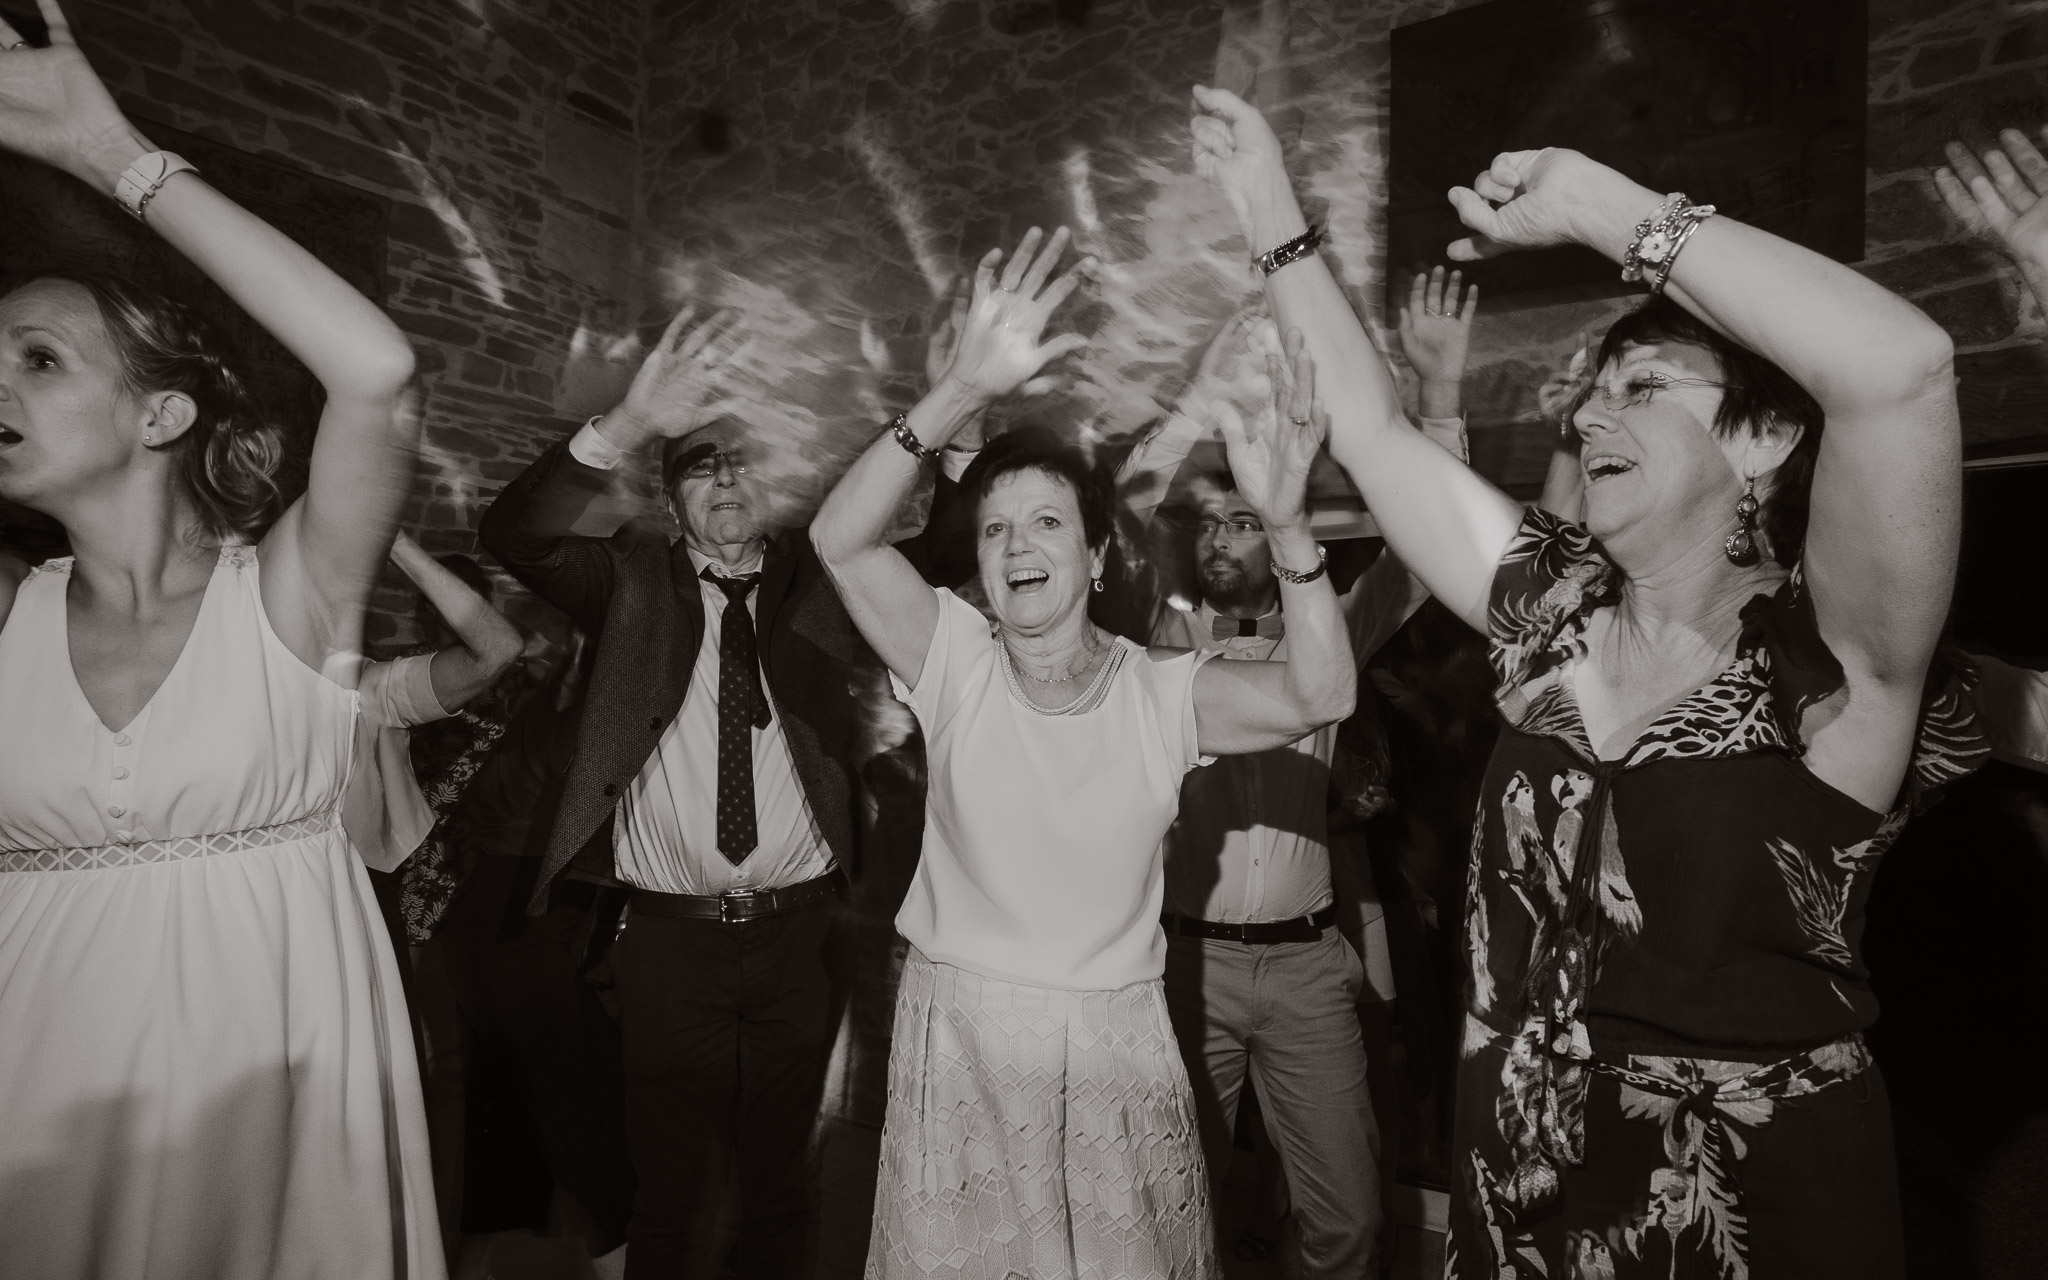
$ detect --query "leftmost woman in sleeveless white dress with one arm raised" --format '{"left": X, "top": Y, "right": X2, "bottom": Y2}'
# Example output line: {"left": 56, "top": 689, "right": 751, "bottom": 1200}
{"left": 0, "top": 0, "right": 442, "bottom": 1280}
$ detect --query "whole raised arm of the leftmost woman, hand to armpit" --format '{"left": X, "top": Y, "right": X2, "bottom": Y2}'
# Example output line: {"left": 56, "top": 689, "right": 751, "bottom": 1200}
{"left": 0, "top": 0, "right": 418, "bottom": 668}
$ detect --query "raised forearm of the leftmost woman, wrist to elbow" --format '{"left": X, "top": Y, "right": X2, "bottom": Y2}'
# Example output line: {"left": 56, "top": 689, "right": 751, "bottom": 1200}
{"left": 74, "top": 129, "right": 414, "bottom": 395}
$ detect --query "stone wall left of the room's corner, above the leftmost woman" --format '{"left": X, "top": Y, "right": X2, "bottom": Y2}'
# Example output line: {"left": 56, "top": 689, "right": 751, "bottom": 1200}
{"left": 6, "top": 0, "right": 645, "bottom": 643}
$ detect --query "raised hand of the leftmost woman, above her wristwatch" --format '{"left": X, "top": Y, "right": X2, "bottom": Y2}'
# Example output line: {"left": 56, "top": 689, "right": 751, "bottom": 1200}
{"left": 0, "top": 0, "right": 143, "bottom": 182}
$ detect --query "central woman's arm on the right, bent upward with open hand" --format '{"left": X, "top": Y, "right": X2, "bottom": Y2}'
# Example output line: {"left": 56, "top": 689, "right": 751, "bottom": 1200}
{"left": 1194, "top": 334, "right": 1358, "bottom": 756}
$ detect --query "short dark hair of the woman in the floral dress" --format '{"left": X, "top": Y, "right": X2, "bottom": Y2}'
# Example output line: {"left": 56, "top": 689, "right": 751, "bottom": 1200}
{"left": 1575, "top": 297, "right": 1825, "bottom": 565}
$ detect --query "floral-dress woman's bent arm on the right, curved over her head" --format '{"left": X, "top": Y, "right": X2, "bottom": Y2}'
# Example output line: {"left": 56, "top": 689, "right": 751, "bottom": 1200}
{"left": 1452, "top": 147, "right": 1962, "bottom": 709}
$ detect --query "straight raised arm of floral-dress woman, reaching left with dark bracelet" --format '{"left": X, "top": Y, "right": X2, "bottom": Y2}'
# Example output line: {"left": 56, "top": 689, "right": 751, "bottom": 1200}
{"left": 1194, "top": 86, "right": 1522, "bottom": 629}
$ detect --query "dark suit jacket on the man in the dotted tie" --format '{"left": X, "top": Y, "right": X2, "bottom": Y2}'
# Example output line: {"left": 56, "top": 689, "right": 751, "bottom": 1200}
{"left": 477, "top": 438, "right": 864, "bottom": 911}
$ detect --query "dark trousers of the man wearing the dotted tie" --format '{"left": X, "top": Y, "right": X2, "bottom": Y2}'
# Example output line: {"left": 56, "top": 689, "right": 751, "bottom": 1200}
{"left": 612, "top": 903, "right": 831, "bottom": 1280}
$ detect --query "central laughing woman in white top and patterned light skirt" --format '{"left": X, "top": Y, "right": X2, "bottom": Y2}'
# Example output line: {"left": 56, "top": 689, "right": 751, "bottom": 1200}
{"left": 811, "top": 229, "right": 1356, "bottom": 1280}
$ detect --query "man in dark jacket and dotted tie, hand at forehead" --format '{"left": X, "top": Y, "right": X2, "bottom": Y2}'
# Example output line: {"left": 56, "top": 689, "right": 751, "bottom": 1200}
{"left": 479, "top": 315, "right": 880, "bottom": 1280}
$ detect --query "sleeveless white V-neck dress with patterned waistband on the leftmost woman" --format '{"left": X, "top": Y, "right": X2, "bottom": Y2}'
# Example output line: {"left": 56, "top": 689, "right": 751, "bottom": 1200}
{"left": 0, "top": 547, "right": 444, "bottom": 1280}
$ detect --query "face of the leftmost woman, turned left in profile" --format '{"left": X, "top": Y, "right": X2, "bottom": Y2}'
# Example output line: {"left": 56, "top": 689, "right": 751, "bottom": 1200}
{"left": 0, "top": 281, "right": 147, "bottom": 514}
